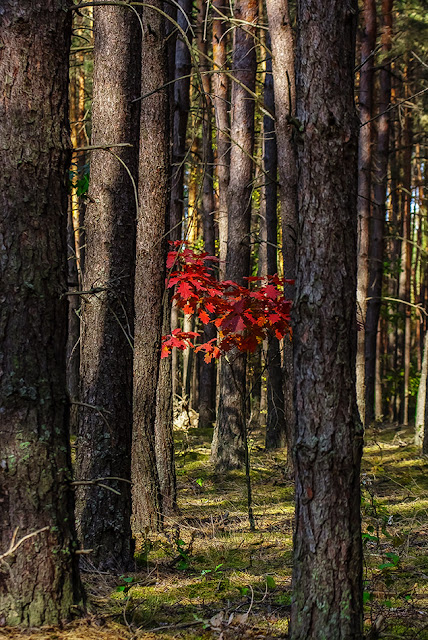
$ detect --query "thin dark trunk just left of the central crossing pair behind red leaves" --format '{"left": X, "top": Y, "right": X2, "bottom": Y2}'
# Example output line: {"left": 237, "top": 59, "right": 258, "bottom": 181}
{"left": 197, "top": 1, "right": 217, "bottom": 428}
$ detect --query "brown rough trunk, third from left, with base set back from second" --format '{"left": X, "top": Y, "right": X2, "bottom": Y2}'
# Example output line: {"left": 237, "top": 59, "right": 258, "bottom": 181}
{"left": 132, "top": 0, "right": 170, "bottom": 535}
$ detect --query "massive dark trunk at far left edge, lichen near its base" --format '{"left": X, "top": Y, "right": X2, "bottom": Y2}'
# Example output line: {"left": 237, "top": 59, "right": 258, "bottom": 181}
{"left": 0, "top": 0, "right": 81, "bottom": 627}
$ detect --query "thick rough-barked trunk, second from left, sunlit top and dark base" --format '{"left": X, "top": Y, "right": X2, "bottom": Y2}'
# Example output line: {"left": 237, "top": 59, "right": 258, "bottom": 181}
{"left": 76, "top": 7, "right": 141, "bottom": 571}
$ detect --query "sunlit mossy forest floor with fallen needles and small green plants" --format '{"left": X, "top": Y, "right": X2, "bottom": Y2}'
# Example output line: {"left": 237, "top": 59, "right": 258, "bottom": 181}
{"left": 0, "top": 420, "right": 428, "bottom": 640}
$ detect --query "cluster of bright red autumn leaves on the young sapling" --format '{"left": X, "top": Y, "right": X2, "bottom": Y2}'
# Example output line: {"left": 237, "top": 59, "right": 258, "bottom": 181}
{"left": 162, "top": 242, "right": 291, "bottom": 362}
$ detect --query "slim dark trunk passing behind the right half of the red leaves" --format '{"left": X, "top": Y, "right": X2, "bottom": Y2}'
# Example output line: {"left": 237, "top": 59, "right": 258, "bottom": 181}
{"left": 262, "top": 34, "right": 287, "bottom": 449}
